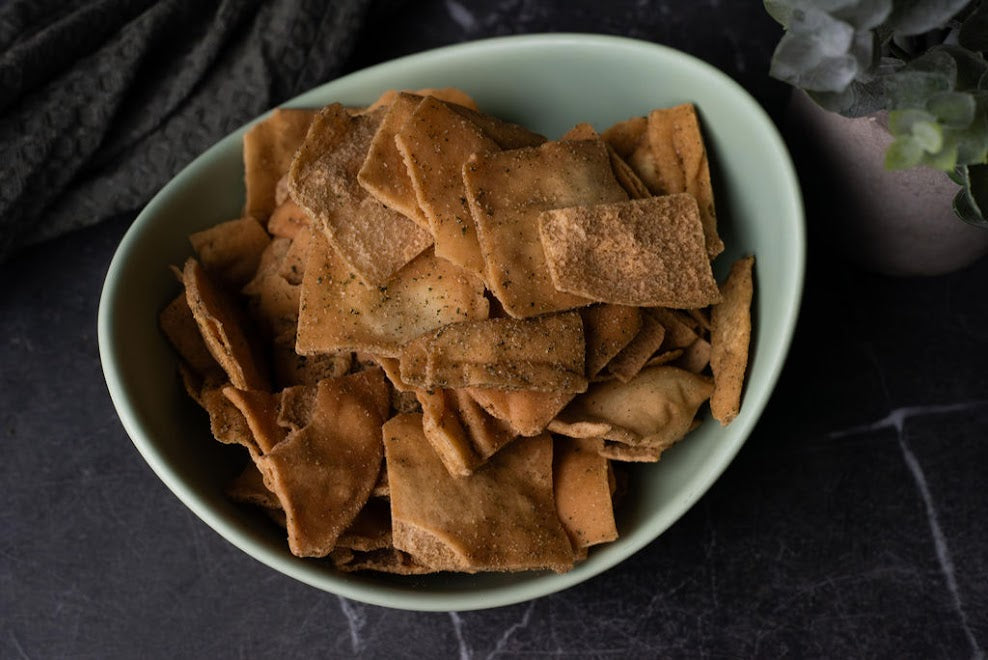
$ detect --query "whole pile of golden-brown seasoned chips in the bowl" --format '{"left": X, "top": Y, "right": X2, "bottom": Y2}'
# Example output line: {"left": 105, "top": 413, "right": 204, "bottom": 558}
{"left": 160, "top": 89, "right": 753, "bottom": 574}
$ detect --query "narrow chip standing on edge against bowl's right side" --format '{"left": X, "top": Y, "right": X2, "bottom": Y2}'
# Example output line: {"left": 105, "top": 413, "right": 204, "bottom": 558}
{"left": 710, "top": 257, "right": 755, "bottom": 425}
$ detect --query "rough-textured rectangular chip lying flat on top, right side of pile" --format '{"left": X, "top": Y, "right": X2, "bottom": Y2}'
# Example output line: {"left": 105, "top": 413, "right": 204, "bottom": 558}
{"left": 539, "top": 194, "right": 720, "bottom": 308}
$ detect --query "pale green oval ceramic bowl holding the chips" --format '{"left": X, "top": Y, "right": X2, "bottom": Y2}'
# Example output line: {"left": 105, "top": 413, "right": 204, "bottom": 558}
{"left": 99, "top": 34, "right": 804, "bottom": 610}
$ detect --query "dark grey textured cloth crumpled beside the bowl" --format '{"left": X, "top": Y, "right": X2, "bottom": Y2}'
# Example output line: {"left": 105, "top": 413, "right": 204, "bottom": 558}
{"left": 0, "top": 0, "right": 370, "bottom": 261}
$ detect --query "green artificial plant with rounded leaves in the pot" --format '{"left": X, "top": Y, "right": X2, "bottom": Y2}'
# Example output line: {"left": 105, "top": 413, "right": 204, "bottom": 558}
{"left": 765, "top": 0, "right": 988, "bottom": 227}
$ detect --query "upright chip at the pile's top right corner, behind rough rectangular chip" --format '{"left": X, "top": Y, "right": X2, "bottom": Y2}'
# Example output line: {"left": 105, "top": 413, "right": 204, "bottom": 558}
{"left": 648, "top": 103, "right": 724, "bottom": 259}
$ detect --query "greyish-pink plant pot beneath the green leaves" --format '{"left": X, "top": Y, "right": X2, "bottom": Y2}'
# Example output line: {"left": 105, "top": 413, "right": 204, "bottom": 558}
{"left": 787, "top": 90, "right": 988, "bottom": 275}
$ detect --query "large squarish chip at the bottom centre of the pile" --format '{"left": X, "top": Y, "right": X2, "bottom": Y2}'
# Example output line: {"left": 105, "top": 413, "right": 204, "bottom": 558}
{"left": 384, "top": 415, "right": 574, "bottom": 573}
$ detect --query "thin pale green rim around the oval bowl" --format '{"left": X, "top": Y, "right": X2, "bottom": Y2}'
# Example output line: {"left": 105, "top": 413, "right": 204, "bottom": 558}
{"left": 97, "top": 33, "right": 806, "bottom": 612}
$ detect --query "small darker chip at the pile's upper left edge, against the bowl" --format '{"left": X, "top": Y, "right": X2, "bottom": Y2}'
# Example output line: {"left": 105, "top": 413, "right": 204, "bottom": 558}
{"left": 189, "top": 217, "right": 271, "bottom": 289}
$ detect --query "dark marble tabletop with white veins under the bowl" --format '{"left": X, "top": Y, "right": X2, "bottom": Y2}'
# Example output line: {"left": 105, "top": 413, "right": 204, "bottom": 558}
{"left": 0, "top": 0, "right": 988, "bottom": 658}
